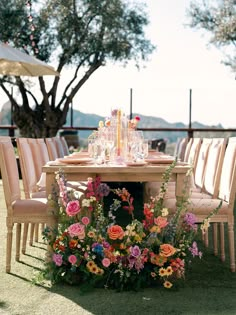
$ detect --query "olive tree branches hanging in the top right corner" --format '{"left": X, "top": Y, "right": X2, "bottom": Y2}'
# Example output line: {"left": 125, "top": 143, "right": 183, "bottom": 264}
{"left": 187, "top": 0, "right": 236, "bottom": 71}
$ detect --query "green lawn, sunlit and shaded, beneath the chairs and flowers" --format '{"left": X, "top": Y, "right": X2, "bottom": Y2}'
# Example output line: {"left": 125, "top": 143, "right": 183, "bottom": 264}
{"left": 0, "top": 180, "right": 236, "bottom": 315}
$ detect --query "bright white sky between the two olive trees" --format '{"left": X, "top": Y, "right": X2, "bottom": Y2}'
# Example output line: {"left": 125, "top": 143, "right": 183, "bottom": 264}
{"left": 69, "top": 0, "right": 236, "bottom": 128}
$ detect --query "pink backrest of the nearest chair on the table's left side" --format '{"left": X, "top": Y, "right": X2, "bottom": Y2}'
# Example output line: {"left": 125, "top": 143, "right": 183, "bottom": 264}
{"left": 0, "top": 136, "right": 21, "bottom": 207}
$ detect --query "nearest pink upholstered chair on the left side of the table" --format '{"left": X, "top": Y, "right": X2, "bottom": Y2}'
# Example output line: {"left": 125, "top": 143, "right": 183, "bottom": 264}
{"left": 0, "top": 137, "right": 56, "bottom": 273}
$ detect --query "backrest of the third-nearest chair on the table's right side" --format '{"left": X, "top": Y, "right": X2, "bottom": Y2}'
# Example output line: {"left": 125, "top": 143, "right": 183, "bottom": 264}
{"left": 194, "top": 138, "right": 212, "bottom": 188}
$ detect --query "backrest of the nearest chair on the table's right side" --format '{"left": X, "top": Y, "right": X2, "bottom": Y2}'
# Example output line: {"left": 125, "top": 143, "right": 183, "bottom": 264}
{"left": 218, "top": 137, "right": 236, "bottom": 203}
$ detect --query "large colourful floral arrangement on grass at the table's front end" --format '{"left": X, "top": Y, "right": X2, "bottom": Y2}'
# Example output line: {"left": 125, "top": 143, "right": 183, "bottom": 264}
{"left": 43, "top": 162, "right": 219, "bottom": 290}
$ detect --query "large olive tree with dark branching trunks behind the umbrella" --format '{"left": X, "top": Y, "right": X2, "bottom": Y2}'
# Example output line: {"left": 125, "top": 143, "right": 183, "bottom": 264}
{"left": 0, "top": 0, "right": 155, "bottom": 137}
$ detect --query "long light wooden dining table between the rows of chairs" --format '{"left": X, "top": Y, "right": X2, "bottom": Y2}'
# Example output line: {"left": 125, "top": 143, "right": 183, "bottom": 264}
{"left": 43, "top": 163, "right": 190, "bottom": 199}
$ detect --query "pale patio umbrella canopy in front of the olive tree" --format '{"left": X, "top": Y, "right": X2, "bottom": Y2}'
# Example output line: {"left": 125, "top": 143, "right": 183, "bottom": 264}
{"left": 0, "top": 43, "right": 60, "bottom": 77}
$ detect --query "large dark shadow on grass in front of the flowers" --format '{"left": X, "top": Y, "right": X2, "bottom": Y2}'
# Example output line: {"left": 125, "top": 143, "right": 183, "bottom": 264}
{"left": 40, "top": 250, "right": 236, "bottom": 315}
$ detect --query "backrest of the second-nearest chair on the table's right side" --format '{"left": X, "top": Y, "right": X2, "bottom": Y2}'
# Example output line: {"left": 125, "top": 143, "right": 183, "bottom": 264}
{"left": 203, "top": 138, "right": 228, "bottom": 198}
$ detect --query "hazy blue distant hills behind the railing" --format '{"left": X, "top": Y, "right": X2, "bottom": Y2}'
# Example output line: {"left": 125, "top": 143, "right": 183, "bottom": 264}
{"left": 67, "top": 110, "right": 223, "bottom": 143}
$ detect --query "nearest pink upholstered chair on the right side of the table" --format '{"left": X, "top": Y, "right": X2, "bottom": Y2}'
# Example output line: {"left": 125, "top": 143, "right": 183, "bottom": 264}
{"left": 165, "top": 137, "right": 236, "bottom": 272}
